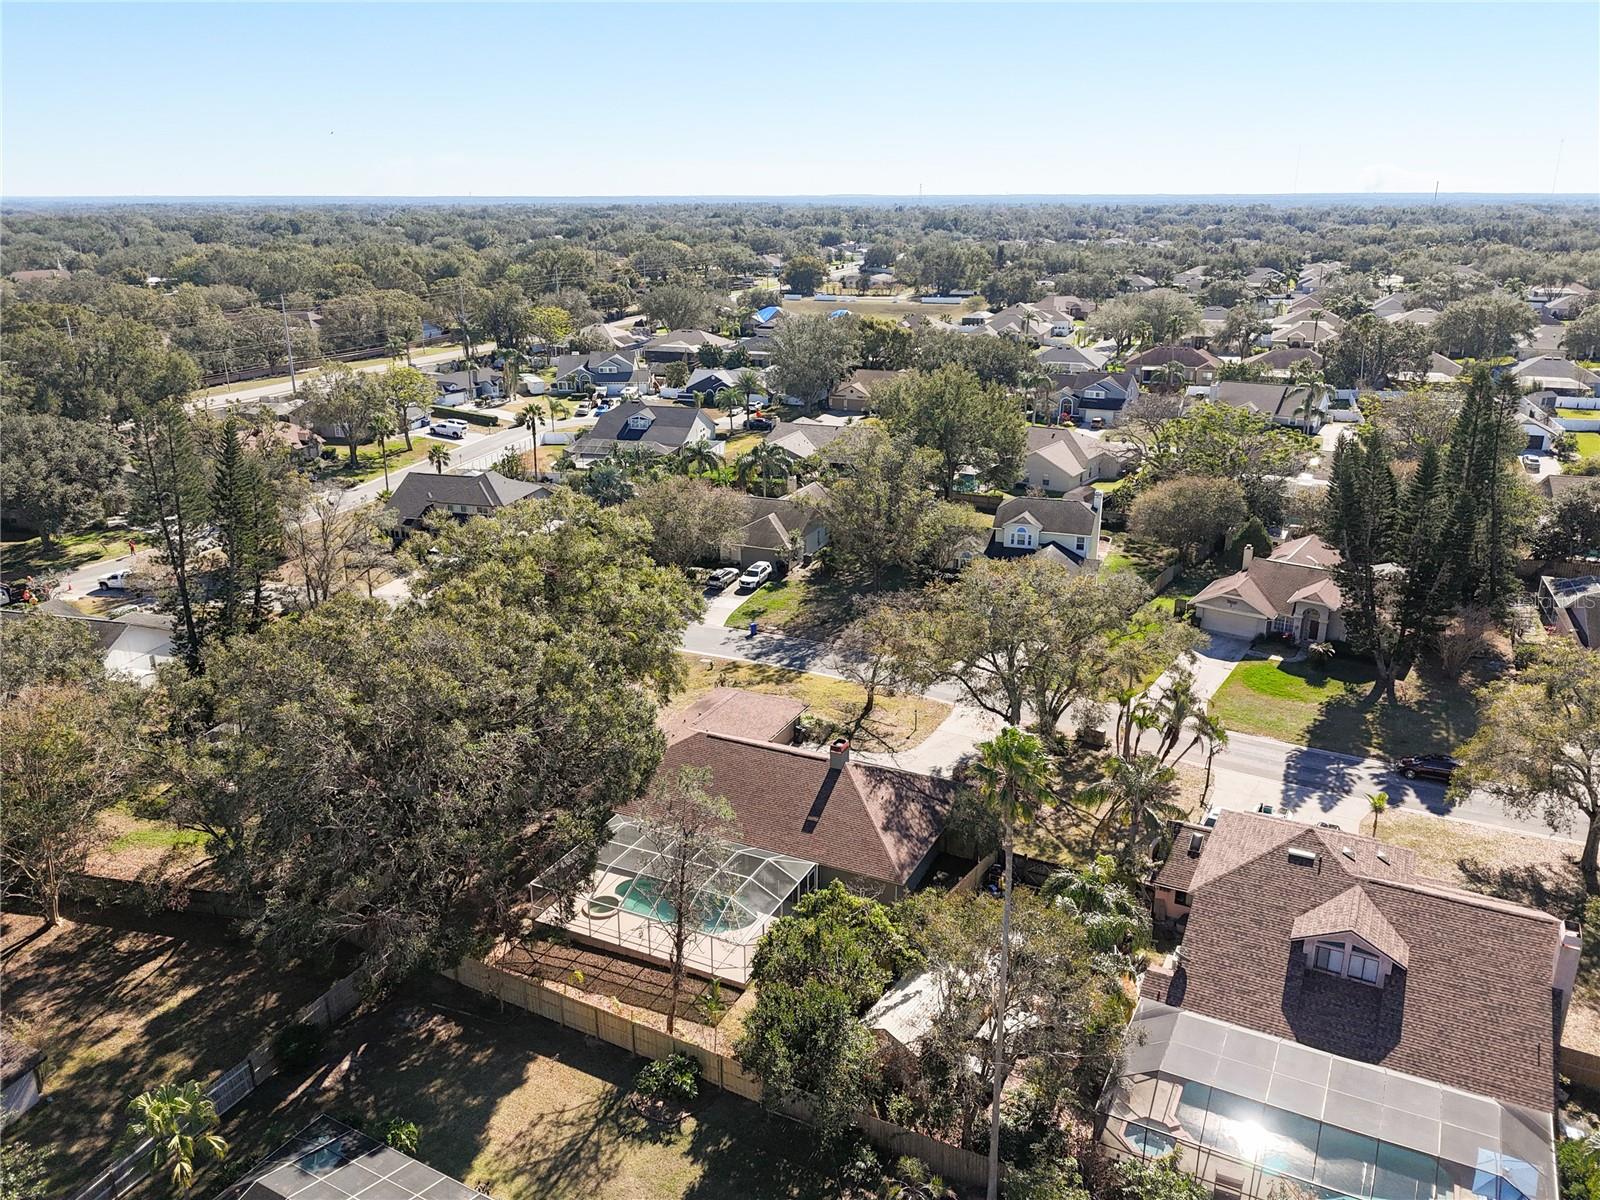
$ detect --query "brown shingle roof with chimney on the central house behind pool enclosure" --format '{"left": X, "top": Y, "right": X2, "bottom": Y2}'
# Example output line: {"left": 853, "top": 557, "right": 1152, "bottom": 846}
{"left": 640, "top": 731, "right": 957, "bottom": 885}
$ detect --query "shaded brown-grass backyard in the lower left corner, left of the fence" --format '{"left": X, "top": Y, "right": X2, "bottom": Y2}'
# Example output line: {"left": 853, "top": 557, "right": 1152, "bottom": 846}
{"left": 0, "top": 909, "right": 340, "bottom": 1195}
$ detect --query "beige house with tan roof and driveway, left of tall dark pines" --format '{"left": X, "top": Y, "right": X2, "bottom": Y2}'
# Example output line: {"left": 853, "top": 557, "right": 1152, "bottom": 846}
{"left": 1189, "top": 534, "right": 1344, "bottom": 642}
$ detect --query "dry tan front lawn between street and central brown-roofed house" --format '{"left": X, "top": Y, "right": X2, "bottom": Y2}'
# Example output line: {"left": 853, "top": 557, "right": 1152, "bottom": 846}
{"left": 661, "top": 654, "right": 950, "bottom": 752}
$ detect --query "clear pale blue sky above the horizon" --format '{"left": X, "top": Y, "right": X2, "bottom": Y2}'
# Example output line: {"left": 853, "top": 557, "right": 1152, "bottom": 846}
{"left": 0, "top": 2, "right": 1600, "bottom": 197}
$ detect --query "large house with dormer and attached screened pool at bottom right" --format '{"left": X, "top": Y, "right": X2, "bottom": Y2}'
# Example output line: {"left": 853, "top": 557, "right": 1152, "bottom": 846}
{"left": 1098, "top": 811, "right": 1561, "bottom": 1200}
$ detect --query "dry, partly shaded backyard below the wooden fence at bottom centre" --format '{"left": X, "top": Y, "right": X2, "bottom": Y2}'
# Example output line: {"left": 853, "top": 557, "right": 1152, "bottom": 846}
{"left": 180, "top": 981, "right": 842, "bottom": 1200}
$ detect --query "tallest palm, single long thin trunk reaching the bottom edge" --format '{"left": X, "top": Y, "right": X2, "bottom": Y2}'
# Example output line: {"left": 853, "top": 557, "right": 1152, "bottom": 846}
{"left": 973, "top": 725, "right": 1056, "bottom": 1200}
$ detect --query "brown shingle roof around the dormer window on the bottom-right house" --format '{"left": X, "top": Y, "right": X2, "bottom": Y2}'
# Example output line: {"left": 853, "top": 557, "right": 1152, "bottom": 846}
{"left": 1165, "top": 813, "right": 1562, "bottom": 1112}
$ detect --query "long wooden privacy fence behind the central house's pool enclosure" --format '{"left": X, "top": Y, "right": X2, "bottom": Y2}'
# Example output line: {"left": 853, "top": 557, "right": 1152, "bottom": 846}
{"left": 443, "top": 958, "right": 989, "bottom": 1186}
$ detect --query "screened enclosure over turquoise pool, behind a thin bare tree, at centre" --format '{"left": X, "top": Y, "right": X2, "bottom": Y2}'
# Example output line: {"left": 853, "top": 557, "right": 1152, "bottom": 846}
{"left": 562, "top": 816, "right": 816, "bottom": 984}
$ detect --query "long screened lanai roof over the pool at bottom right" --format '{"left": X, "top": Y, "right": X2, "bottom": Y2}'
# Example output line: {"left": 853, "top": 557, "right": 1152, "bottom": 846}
{"left": 1110, "top": 1000, "right": 1557, "bottom": 1200}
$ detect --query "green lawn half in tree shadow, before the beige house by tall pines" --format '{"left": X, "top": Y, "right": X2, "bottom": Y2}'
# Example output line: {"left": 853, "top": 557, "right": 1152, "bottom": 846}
{"left": 1211, "top": 658, "right": 1477, "bottom": 757}
